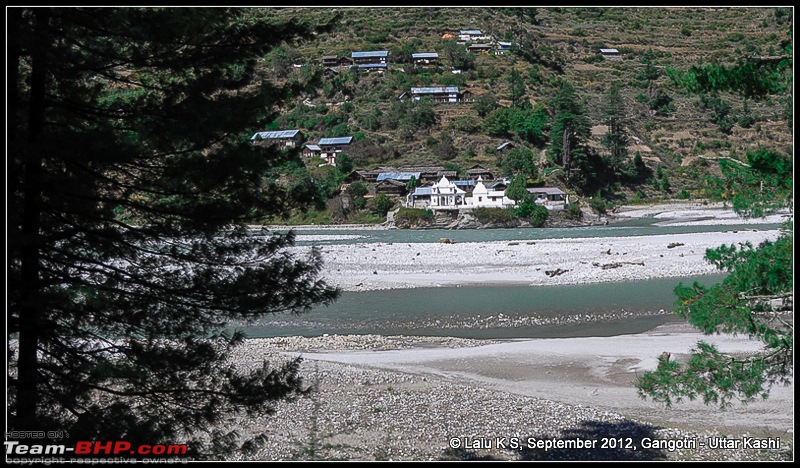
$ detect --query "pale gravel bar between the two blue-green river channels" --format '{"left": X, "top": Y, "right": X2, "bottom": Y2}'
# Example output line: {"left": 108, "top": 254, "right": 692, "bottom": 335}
{"left": 292, "top": 228, "right": 780, "bottom": 291}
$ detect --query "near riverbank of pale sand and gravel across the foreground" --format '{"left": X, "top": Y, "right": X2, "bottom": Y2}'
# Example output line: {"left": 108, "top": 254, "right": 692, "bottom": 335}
{"left": 225, "top": 324, "right": 794, "bottom": 460}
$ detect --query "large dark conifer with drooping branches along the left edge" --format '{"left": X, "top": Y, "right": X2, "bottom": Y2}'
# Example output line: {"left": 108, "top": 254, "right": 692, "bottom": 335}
{"left": 7, "top": 8, "right": 338, "bottom": 456}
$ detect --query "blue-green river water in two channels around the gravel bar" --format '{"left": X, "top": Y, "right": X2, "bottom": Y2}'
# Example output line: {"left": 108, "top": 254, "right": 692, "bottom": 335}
{"left": 231, "top": 219, "right": 780, "bottom": 338}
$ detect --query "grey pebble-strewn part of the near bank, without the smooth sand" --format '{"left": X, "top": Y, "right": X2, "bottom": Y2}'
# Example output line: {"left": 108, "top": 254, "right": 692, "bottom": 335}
{"left": 222, "top": 335, "right": 793, "bottom": 461}
